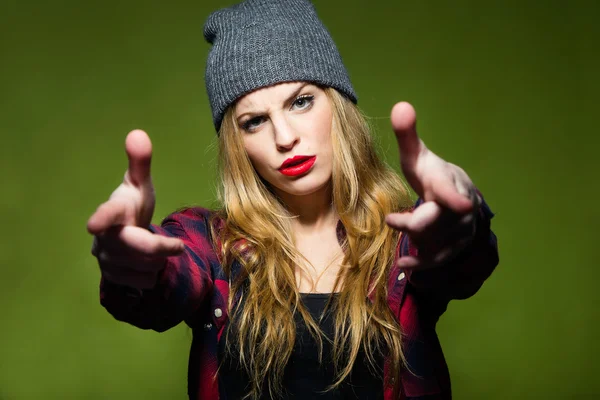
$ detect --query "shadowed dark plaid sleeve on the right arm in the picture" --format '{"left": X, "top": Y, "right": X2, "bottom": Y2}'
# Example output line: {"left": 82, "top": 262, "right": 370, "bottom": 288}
{"left": 400, "top": 194, "right": 499, "bottom": 301}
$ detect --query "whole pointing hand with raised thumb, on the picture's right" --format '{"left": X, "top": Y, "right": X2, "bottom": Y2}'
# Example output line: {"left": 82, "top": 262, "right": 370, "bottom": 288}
{"left": 386, "top": 102, "right": 481, "bottom": 268}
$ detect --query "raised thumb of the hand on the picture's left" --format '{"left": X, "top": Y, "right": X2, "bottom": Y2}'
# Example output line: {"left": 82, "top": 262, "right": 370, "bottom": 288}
{"left": 125, "top": 129, "right": 152, "bottom": 186}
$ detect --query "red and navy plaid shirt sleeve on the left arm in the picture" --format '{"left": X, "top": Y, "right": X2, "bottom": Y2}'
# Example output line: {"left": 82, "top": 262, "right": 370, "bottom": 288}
{"left": 100, "top": 208, "right": 217, "bottom": 332}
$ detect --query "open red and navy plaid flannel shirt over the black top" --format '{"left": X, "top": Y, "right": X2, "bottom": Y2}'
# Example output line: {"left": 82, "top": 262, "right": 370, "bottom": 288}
{"left": 100, "top": 200, "right": 498, "bottom": 400}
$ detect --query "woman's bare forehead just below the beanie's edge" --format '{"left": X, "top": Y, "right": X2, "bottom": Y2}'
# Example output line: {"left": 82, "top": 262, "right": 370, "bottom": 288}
{"left": 235, "top": 82, "right": 315, "bottom": 115}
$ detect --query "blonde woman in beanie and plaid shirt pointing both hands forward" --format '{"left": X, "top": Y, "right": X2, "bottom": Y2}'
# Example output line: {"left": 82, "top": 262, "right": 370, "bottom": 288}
{"left": 88, "top": 0, "right": 498, "bottom": 399}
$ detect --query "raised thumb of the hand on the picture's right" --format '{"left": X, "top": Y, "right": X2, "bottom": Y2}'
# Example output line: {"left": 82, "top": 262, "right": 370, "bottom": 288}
{"left": 391, "top": 101, "right": 424, "bottom": 166}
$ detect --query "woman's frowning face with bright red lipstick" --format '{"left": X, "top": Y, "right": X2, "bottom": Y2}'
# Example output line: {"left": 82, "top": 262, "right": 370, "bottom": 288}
{"left": 235, "top": 82, "right": 333, "bottom": 198}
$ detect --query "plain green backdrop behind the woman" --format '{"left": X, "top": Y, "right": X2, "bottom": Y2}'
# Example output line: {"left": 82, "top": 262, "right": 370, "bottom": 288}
{"left": 0, "top": 0, "right": 600, "bottom": 400}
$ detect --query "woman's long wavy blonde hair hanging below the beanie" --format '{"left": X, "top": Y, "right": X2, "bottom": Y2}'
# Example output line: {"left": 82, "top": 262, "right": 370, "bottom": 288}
{"left": 212, "top": 88, "right": 412, "bottom": 398}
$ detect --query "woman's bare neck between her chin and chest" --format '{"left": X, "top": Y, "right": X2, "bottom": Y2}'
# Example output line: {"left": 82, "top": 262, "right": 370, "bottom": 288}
{"left": 279, "top": 185, "right": 338, "bottom": 235}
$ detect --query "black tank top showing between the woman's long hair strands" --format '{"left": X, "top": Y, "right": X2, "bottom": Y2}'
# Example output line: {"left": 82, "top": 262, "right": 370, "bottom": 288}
{"left": 219, "top": 293, "right": 383, "bottom": 400}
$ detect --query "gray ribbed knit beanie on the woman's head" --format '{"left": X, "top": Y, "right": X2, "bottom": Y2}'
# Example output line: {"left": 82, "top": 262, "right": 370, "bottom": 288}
{"left": 204, "top": 0, "right": 357, "bottom": 132}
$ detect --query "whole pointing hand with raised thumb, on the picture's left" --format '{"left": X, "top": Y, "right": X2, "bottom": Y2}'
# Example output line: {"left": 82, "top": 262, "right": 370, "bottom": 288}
{"left": 87, "top": 130, "right": 184, "bottom": 289}
